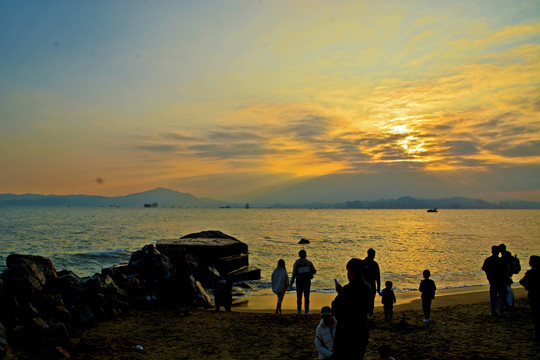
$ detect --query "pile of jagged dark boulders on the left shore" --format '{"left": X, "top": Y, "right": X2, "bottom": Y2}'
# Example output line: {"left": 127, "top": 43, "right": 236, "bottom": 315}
{"left": 0, "top": 245, "right": 212, "bottom": 359}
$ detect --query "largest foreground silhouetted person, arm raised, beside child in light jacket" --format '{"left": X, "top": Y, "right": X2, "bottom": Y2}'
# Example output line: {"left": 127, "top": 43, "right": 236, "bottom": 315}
{"left": 332, "top": 258, "right": 373, "bottom": 359}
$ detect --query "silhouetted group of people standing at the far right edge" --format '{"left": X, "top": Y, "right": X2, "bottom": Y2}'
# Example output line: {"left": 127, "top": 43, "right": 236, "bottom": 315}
{"left": 482, "top": 244, "right": 540, "bottom": 341}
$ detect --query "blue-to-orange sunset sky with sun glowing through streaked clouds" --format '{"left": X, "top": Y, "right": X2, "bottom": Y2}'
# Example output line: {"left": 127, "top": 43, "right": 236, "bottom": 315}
{"left": 0, "top": 0, "right": 540, "bottom": 202}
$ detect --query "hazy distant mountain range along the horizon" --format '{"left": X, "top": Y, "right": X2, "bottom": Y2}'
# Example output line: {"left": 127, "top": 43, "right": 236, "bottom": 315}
{"left": 0, "top": 188, "right": 540, "bottom": 209}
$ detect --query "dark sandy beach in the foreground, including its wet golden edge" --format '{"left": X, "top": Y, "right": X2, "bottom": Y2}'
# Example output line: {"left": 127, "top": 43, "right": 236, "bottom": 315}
{"left": 39, "top": 287, "right": 540, "bottom": 360}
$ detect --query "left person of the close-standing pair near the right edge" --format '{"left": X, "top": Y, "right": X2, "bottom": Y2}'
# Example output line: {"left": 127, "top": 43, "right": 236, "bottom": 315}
{"left": 482, "top": 246, "right": 507, "bottom": 316}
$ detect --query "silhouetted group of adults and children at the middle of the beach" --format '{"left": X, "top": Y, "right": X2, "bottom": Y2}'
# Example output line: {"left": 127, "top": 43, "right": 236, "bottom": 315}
{"left": 272, "top": 249, "right": 436, "bottom": 359}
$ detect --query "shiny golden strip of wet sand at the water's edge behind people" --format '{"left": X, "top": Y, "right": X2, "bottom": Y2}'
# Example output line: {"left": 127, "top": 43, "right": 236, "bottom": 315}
{"left": 232, "top": 283, "right": 527, "bottom": 314}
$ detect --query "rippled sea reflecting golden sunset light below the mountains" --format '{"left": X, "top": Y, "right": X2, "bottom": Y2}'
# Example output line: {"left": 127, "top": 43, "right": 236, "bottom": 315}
{"left": 0, "top": 207, "right": 540, "bottom": 294}
